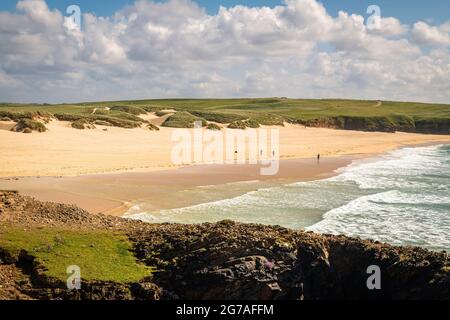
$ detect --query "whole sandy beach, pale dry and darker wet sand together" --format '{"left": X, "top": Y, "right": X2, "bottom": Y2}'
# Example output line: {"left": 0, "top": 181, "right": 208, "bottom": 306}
{"left": 0, "top": 121, "right": 450, "bottom": 215}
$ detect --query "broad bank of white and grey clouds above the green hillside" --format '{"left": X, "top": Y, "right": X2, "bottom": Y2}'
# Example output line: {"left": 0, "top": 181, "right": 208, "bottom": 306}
{"left": 0, "top": 0, "right": 450, "bottom": 102}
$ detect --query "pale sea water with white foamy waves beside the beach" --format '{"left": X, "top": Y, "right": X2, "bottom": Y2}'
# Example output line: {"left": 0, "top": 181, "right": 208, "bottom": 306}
{"left": 129, "top": 145, "right": 450, "bottom": 251}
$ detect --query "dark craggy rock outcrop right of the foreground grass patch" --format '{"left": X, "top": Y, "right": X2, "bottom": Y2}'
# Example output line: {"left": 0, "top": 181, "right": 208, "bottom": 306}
{"left": 131, "top": 221, "right": 450, "bottom": 299}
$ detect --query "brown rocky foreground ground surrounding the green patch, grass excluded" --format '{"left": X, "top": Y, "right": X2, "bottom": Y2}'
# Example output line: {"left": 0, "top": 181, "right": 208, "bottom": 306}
{"left": 0, "top": 192, "right": 450, "bottom": 300}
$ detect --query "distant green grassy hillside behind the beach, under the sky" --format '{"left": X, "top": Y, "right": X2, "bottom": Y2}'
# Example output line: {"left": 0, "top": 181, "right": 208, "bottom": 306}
{"left": 0, "top": 98, "right": 450, "bottom": 134}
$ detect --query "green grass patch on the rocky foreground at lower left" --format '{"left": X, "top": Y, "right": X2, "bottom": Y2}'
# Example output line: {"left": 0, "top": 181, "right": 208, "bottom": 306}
{"left": 0, "top": 226, "right": 152, "bottom": 283}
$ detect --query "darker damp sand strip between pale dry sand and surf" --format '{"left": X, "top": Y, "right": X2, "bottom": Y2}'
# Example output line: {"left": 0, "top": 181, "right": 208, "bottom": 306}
{"left": 0, "top": 157, "right": 353, "bottom": 215}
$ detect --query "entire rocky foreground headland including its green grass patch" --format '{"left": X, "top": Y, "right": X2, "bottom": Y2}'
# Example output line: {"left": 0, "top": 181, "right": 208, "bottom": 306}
{"left": 0, "top": 191, "right": 449, "bottom": 300}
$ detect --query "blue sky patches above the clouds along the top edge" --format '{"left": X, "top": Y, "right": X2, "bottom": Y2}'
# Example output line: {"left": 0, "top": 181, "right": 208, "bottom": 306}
{"left": 0, "top": 0, "right": 450, "bottom": 24}
